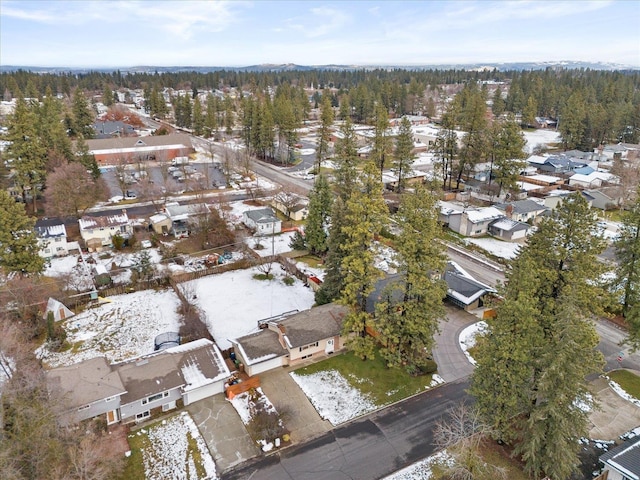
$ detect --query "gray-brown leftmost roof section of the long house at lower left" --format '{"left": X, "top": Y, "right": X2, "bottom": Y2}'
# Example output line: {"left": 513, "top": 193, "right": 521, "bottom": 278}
{"left": 46, "top": 357, "right": 126, "bottom": 408}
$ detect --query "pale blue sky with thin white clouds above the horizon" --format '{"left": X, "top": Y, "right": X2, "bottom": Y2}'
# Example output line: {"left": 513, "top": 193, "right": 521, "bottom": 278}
{"left": 0, "top": 0, "right": 640, "bottom": 67}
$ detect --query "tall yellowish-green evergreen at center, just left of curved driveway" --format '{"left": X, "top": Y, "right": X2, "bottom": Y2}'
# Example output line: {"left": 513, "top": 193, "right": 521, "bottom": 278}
{"left": 375, "top": 186, "right": 447, "bottom": 372}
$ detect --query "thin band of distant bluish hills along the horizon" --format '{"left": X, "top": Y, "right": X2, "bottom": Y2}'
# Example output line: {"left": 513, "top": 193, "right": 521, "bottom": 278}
{"left": 0, "top": 61, "right": 640, "bottom": 73}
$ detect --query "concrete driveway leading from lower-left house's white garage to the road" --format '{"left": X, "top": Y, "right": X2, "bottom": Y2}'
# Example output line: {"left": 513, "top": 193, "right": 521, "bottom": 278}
{"left": 186, "top": 394, "right": 261, "bottom": 472}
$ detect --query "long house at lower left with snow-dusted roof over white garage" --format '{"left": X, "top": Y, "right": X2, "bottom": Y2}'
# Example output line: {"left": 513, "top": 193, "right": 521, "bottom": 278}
{"left": 47, "top": 338, "right": 230, "bottom": 424}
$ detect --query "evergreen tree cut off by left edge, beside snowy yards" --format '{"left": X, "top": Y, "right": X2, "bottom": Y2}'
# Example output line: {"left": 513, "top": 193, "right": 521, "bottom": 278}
{"left": 0, "top": 190, "right": 45, "bottom": 273}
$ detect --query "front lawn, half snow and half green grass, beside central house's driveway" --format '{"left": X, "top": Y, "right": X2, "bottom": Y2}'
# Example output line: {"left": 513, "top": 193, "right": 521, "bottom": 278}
{"left": 290, "top": 353, "right": 443, "bottom": 425}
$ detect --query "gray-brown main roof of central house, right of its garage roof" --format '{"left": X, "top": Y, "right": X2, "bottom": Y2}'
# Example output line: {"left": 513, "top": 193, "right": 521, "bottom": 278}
{"left": 278, "top": 303, "right": 347, "bottom": 348}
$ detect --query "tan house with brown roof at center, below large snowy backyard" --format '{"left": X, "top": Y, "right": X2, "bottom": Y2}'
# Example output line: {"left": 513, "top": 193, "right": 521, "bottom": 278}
{"left": 231, "top": 303, "right": 347, "bottom": 375}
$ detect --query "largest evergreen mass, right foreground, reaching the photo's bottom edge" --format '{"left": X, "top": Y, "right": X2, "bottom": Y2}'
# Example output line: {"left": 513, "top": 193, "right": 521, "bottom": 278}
{"left": 471, "top": 193, "right": 604, "bottom": 479}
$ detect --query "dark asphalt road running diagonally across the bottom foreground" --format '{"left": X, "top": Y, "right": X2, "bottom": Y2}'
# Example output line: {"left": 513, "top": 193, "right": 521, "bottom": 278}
{"left": 221, "top": 382, "right": 468, "bottom": 480}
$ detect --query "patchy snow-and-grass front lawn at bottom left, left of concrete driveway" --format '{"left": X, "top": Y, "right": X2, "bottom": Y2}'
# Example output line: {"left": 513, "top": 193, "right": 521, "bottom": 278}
{"left": 129, "top": 412, "right": 218, "bottom": 480}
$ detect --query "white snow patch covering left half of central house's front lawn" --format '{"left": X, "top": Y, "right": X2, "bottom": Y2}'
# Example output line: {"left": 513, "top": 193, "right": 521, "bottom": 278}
{"left": 289, "top": 370, "right": 378, "bottom": 425}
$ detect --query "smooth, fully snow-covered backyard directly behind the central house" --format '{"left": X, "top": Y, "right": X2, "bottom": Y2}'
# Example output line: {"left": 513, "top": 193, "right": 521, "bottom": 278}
{"left": 182, "top": 263, "right": 315, "bottom": 350}
